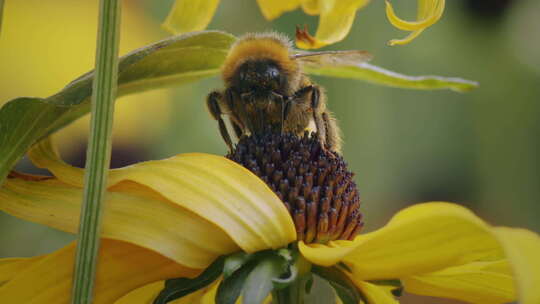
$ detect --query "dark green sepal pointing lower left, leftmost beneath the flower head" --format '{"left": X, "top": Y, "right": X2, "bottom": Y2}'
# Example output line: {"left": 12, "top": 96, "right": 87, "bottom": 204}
{"left": 154, "top": 257, "right": 225, "bottom": 304}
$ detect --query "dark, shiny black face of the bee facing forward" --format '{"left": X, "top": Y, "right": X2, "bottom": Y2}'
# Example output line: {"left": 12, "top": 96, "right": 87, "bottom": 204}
{"left": 233, "top": 59, "right": 285, "bottom": 92}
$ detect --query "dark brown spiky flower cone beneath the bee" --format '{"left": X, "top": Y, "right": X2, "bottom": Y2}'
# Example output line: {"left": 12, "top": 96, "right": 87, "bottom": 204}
{"left": 227, "top": 132, "right": 364, "bottom": 243}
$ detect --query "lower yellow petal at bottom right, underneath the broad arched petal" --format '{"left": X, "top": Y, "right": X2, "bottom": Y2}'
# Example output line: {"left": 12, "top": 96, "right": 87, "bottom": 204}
{"left": 401, "top": 260, "right": 516, "bottom": 304}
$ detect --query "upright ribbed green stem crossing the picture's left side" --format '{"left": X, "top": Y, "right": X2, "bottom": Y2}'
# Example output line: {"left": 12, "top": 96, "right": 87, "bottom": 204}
{"left": 71, "top": 0, "right": 120, "bottom": 304}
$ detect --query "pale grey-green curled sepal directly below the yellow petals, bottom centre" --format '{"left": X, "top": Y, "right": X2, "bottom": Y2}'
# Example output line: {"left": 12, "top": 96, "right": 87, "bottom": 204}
{"left": 242, "top": 256, "right": 287, "bottom": 304}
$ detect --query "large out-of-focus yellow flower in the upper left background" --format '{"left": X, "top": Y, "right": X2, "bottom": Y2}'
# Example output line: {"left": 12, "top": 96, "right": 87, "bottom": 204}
{"left": 0, "top": 0, "right": 170, "bottom": 155}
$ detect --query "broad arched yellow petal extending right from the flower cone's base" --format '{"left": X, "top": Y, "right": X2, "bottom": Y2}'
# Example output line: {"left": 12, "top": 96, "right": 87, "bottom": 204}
{"left": 299, "top": 203, "right": 503, "bottom": 280}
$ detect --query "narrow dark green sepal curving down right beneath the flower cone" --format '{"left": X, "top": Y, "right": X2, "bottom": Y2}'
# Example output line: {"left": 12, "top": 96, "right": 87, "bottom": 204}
{"left": 312, "top": 265, "right": 367, "bottom": 304}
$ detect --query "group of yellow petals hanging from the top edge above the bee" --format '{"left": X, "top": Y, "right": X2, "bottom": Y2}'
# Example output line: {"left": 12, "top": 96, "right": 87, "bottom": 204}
{"left": 163, "top": 0, "right": 445, "bottom": 49}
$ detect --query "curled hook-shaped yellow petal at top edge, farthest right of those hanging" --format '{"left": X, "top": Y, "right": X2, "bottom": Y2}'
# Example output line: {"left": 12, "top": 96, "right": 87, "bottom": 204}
{"left": 386, "top": 0, "right": 445, "bottom": 45}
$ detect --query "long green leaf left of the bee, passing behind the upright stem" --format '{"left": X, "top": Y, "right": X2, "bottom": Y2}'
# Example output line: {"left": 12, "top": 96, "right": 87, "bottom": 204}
{"left": 0, "top": 31, "right": 236, "bottom": 183}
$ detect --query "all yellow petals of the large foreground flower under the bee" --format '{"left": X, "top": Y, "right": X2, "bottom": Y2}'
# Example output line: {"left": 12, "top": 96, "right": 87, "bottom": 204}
{"left": 0, "top": 140, "right": 540, "bottom": 304}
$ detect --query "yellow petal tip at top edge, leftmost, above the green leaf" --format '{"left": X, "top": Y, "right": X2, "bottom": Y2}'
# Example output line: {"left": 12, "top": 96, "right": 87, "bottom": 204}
{"left": 161, "top": 0, "right": 219, "bottom": 34}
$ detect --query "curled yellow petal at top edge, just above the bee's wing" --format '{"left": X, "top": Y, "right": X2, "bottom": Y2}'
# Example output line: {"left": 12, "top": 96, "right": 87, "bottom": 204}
{"left": 296, "top": 0, "right": 369, "bottom": 49}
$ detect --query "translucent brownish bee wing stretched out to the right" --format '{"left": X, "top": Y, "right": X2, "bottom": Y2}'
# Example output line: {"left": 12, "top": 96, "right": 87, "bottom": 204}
{"left": 291, "top": 51, "right": 373, "bottom": 68}
